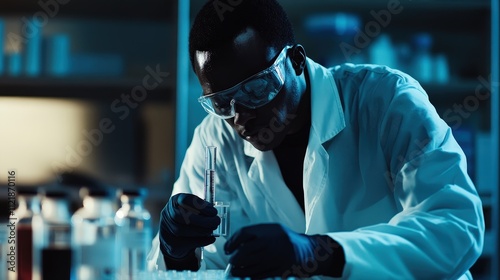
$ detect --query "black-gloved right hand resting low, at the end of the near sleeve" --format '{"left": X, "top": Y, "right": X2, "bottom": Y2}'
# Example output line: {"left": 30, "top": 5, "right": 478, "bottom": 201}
{"left": 224, "top": 224, "right": 345, "bottom": 278}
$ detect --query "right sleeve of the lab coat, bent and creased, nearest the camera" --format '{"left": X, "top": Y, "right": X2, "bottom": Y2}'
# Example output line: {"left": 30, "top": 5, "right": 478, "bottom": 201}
{"left": 329, "top": 76, "right": 484, "bottom": 279}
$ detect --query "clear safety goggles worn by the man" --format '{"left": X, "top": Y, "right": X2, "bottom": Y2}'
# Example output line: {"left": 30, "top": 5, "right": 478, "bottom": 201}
{"left": 198, "top": 46, "right": 291, "bottom": 119}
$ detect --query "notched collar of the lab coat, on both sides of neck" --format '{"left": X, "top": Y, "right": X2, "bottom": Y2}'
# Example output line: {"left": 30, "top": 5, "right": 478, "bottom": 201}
{"left": 243, "top": 58, "right": 346, "bottom": 158}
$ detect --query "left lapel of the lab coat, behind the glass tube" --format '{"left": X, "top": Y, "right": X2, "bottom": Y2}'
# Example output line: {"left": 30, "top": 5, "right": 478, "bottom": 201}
{"left": 243, "top": 142, "right": 305, "bottom": 232}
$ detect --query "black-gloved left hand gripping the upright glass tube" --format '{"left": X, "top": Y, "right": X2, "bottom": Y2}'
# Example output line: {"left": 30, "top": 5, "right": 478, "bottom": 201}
{"left": 159, "top": 193, "right": 220, "bottom": 270}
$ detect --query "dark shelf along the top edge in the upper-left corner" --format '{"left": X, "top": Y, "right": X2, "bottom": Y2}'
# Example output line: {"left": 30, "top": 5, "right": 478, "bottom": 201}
{"left": 0, "top": 0, "right": 177, "bottom": 20}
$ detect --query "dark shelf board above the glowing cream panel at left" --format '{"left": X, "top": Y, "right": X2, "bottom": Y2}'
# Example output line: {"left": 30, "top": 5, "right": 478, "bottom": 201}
{"left": 0, "top": 78, "right": 174, "bottom": 101}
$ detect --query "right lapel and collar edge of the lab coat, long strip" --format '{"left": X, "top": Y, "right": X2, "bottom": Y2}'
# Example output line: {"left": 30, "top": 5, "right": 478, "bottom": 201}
{"left": 304, "top": 59, "right": 346, "bottom": 233}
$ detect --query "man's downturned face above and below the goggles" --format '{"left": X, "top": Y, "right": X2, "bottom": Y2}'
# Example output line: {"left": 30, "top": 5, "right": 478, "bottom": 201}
{"left": 195, "top": 28, "right": 301, "bottom": 151}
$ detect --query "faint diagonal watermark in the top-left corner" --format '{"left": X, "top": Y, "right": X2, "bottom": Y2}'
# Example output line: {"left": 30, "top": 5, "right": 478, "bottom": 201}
{"left": 7, "top": 0, "right": 71, "bottom": 48}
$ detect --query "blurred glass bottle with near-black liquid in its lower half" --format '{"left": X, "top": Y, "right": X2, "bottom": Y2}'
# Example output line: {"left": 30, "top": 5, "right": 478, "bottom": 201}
{"left": 33, "top": 189, "right": 74, "bottom": 280}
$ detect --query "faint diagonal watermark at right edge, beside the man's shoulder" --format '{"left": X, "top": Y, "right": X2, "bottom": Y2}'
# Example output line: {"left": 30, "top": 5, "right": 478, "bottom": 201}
{"left": 443, "top": 75, "right": 499, "bottom": 129}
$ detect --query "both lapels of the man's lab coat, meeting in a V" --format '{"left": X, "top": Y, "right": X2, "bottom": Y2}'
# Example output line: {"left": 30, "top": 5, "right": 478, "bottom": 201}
{"left": 234, "top": 59, "right": 345, "bottom": 233}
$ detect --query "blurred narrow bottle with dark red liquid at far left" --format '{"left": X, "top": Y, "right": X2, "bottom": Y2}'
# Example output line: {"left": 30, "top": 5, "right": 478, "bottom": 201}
{"left": 16, "top": 187, "right": 40, "bottom": 280}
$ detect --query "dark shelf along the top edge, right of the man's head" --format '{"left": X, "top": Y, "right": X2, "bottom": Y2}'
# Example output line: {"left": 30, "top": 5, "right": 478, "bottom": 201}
{"left": 282, "top": 0, "right": 490, "bottom": 35}
